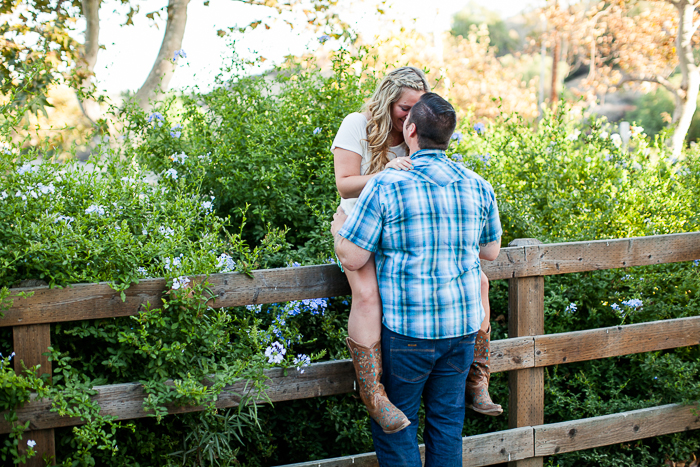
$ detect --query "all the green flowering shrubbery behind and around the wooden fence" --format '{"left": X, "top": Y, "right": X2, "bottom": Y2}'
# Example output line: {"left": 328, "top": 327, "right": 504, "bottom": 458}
{"left": 0, "top": 51, "right": 700, "bottom": 466}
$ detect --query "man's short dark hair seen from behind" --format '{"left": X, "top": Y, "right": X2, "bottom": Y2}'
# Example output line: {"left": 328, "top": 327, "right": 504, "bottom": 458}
{"left": 408, "top": 92, "right": 457, "bottom": 149}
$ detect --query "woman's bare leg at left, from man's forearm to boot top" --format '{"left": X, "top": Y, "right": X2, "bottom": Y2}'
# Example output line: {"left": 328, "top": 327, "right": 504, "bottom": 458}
{"left": 345, "top": 255, "right": 382, "bottom": 347}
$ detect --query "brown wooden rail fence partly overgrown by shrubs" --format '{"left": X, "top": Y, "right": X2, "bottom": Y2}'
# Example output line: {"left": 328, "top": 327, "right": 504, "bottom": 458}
{"left": 0, "top": 232, "right": 700, "bottom": 467}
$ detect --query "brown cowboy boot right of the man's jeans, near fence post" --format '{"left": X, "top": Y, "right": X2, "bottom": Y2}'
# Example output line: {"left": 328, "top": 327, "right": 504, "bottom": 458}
{"left": 465, "top": 326, "right": 503, "bottom": 416}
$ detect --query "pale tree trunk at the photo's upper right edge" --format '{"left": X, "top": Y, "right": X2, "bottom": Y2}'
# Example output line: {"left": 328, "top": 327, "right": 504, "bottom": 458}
{"left": 672, "top": 0, "right": 700, "bottom": 157}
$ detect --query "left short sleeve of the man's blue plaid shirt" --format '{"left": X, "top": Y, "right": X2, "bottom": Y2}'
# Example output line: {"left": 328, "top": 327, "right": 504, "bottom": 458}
{"left": 338, "top": 178, "right": 383, "bottom": 253}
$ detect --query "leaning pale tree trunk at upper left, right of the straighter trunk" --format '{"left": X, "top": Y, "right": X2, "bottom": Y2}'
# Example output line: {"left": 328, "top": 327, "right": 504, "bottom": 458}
{"left": 134, "top": 0, "right": 190, "bottom": 108}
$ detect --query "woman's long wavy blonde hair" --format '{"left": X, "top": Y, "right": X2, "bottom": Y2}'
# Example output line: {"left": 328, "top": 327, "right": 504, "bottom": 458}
{"left": 364, "top": 66, "right": 430, "bottom": 174}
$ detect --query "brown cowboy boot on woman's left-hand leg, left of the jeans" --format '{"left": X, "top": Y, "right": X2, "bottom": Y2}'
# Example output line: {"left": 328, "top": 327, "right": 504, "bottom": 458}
{"left": 346, "top": 337, "right": 411, "bottom": 434}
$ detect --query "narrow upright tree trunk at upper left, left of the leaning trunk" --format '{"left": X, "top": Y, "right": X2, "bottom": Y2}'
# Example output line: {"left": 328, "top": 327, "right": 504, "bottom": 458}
{"left": 78, "top": 0, "right": 102, "bottom": 124}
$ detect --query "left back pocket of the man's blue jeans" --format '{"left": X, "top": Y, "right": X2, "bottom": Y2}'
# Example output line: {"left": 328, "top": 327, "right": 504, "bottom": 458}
{"left": 389, "top": 337, "right": 435, "bottom": 383}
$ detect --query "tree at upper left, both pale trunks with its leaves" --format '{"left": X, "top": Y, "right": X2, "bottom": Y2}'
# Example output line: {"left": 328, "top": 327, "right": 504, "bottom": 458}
{"left": 0, "top": 0, "right": 343, "bottom": 122}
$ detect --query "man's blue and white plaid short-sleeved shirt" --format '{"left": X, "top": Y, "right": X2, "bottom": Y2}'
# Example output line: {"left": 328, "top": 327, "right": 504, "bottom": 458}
{"left": 339, "top": 149, "right": 502, "bottom": 339}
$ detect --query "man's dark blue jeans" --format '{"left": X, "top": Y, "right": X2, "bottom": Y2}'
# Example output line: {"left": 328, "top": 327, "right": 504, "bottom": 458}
{"left": 372, "top": 326, "right": 476, "bottom": 467}
